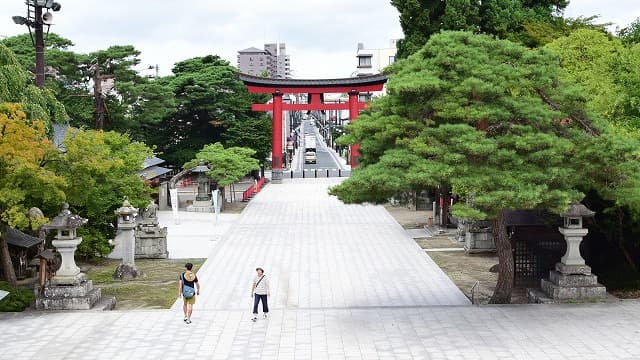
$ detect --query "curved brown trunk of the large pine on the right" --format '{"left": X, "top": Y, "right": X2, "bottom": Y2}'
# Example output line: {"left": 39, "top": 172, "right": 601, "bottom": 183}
{"left": 489, "top": 210, "right": 514, "bottom": 304}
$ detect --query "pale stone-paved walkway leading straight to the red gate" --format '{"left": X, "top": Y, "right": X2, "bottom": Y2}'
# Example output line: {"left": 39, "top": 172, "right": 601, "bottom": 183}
{"left": 177, "top": 178, "right": 469, "bottom": 310}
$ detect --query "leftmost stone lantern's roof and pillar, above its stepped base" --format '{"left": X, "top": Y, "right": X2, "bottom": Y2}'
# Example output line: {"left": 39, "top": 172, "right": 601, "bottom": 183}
{"left": 44, "top": 203, "right": 88, "bottom": 285}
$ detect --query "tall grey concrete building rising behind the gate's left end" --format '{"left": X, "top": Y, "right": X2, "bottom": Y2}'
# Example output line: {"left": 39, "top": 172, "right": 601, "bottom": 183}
{"left": 238, "top": 43, "right": 291, "bottom": 79}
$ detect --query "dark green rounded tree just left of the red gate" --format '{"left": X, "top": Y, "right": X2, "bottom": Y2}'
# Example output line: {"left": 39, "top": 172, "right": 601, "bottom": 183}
{"left": 153, "top": 55, "right": 271, "bottom": 166}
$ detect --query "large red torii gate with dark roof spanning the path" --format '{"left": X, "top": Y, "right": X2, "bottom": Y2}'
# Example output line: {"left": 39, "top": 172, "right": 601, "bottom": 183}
{"left": 240, "top": 74, "right": 387, "bottom": 182}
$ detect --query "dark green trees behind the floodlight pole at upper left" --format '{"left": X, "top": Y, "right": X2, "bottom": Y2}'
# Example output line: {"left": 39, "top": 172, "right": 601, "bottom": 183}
{"left": 2, "top": 34, "right": 176, "bottom": 141}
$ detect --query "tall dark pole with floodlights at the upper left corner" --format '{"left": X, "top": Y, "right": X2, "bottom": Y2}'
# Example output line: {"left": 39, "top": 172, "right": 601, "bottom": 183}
{"left": 12, "top": 0, "right": 62, "bottom": 88}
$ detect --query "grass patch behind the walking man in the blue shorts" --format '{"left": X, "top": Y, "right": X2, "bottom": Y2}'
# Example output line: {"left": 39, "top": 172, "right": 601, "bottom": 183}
{"left": 80, "top": 259, "right": 205, "bottom": 310}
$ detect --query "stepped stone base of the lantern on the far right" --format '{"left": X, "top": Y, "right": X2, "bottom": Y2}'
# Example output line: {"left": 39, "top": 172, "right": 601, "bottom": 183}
{"left": 527, "top": 263, "right": 607, "bottom": 303}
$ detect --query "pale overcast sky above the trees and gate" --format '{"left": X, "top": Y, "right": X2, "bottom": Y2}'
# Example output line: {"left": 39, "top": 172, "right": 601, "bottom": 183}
{"left": 0, "top": 0, "right": 640, "bottom": 78}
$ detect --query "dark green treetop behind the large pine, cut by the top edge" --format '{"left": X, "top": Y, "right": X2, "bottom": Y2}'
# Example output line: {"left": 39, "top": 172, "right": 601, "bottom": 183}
{"left": 391, "top": 0, "right": 568, "bottom": 58}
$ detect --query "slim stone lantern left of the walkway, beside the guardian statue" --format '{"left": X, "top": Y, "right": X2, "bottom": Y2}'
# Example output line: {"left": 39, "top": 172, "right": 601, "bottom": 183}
{"left": 113, "top": 198, "right": 142, "bottom": 279}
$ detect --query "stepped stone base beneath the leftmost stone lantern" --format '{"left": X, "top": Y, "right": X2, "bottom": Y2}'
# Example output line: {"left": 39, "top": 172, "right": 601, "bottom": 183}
{"left": 35, "top": 274, "right": 116, "bottom": 310}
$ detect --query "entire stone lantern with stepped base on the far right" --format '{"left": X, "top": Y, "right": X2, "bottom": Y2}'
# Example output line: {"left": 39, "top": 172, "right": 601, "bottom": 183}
{"left": 528, "top": 203, "right": 607, "bottom": 302}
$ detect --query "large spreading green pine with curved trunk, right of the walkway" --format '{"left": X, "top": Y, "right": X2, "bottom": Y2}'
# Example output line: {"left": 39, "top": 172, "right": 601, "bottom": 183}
{"left": 331, "top": 32, "right": 640, "bottom": 303}
